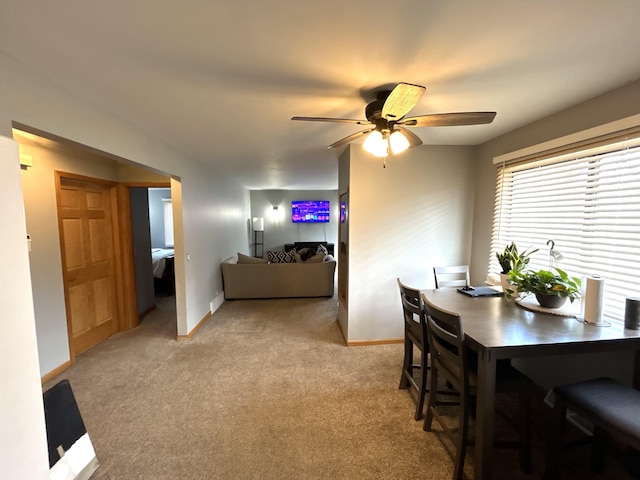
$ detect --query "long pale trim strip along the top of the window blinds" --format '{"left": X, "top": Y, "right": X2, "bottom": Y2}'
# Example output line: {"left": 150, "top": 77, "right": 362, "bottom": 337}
{"left": 493, "top": 114, "right": 640, "bottom": 165}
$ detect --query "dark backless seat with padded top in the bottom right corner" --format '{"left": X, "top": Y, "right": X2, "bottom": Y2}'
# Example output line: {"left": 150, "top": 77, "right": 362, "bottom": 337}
{"left": 544, "top": 377, "right": 640, "bottom": 480}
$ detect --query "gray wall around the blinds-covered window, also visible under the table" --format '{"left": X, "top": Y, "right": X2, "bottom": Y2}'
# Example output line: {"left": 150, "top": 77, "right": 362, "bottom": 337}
{"left": 471, "top": 80, "right": 640, "bottom": 388}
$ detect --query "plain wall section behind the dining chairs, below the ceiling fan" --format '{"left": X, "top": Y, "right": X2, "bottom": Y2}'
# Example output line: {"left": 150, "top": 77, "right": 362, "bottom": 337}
{"left": 341, "top": 146, "right": 475, "bottom": 342}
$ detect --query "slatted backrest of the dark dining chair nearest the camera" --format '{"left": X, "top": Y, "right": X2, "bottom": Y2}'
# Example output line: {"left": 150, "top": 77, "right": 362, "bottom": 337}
{"left": 422, "top": 295, "right": 469, "bottom": 395}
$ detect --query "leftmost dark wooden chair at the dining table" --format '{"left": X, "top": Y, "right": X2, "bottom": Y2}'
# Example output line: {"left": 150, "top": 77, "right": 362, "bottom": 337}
{"left": 396, "top": 278, "right": 429, "bottom": 420}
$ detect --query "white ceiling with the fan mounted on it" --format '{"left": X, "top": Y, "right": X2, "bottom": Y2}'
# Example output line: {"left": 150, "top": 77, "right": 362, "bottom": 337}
{"left": 0, "top": 0, "right": 640, "bottom": 189}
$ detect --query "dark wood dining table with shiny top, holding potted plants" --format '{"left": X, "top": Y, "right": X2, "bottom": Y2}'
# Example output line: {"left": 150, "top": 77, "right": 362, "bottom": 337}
{"left": 422, "top": 288, "right": 640, "bottom": 479}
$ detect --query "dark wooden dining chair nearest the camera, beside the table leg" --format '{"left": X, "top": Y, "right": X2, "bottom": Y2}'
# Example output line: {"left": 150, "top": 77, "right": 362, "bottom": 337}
{"left": 422, "top": 295, "right": 532, "bottom": 480}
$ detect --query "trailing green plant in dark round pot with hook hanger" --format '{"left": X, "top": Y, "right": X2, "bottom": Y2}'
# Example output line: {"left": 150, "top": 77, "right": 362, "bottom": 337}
{"left": 506, "top": 267, "right": 582, "bottom": 308}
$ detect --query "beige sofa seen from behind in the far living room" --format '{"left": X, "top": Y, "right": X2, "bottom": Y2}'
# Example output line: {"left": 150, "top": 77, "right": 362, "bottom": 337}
{"left": 220, "top": 257, "right": 336, "bottom": 300}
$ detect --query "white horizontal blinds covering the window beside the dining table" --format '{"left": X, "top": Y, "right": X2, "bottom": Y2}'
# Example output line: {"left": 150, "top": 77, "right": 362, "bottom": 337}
{"left": 490, "top": 142, "right": 640, "bottom": 321}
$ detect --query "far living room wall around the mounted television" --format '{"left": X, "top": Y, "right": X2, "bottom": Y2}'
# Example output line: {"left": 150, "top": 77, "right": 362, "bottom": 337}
{"left": 249, "top": 190, "right": 340, "bottom": 257}
